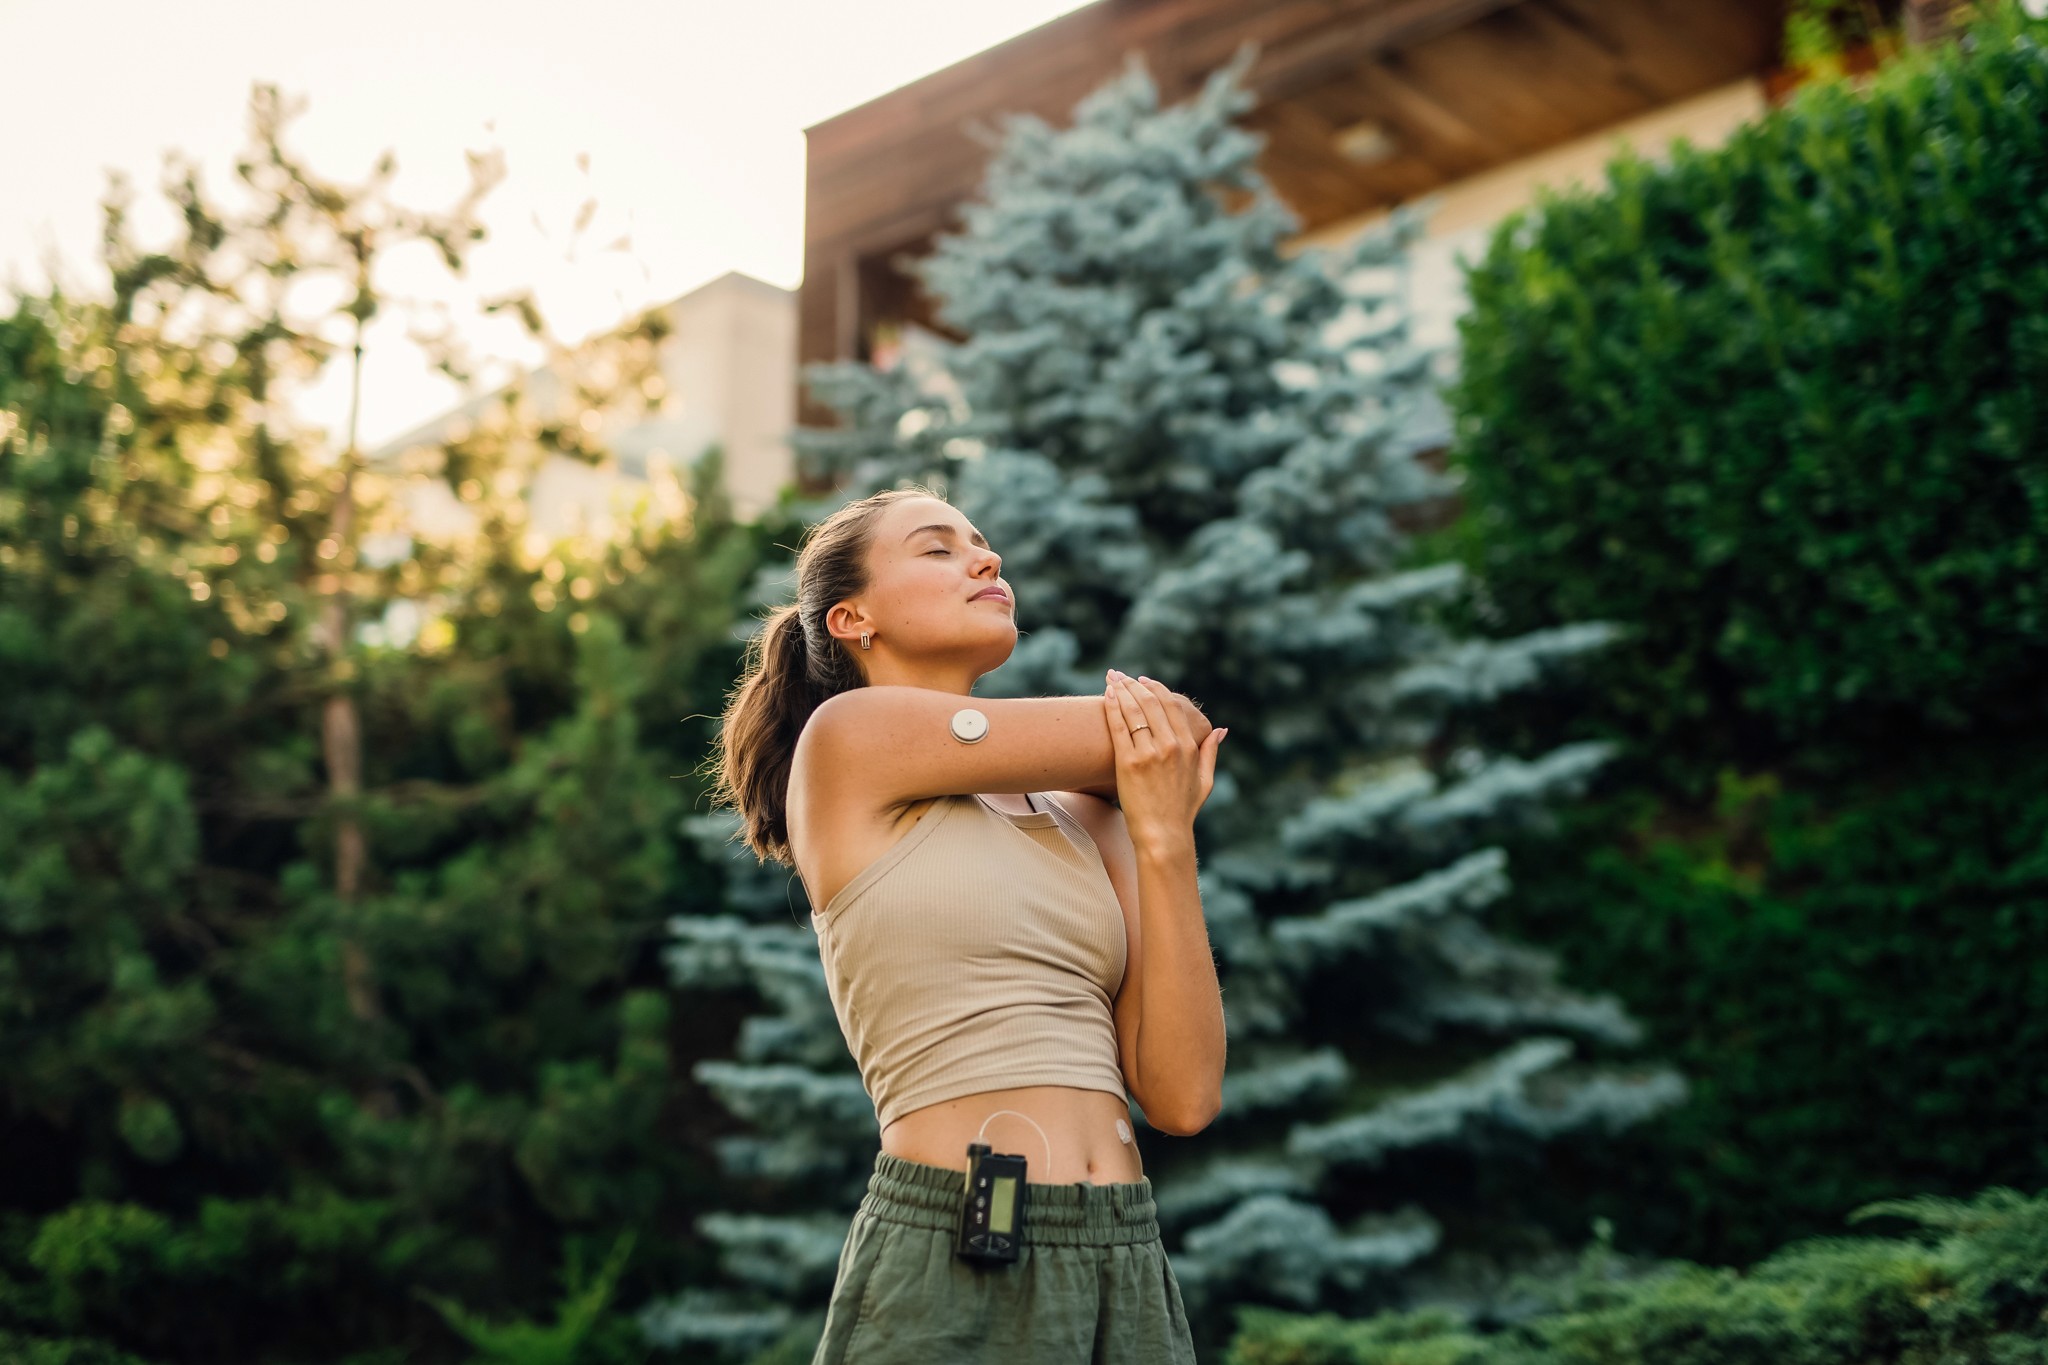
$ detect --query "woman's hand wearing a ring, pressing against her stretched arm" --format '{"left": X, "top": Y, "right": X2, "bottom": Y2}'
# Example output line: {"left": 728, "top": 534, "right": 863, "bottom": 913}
{"left": 1102, "top": 669, "right": 1229, "bottom": 845}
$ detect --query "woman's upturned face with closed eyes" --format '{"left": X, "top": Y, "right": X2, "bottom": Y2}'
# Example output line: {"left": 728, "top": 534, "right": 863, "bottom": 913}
{"left": 834, "top": 497, "right": 1018, "bottom": 692}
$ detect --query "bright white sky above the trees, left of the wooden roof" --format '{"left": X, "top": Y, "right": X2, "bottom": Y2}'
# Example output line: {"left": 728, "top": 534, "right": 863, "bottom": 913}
{"left": 0, "top": 0, "right": 1079, "bottom": 446}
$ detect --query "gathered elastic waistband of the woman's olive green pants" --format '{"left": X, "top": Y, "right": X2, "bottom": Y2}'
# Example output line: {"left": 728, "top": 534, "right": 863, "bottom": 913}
{"left": 860, "top": 1152, "right": 1159, "bottom": 1246}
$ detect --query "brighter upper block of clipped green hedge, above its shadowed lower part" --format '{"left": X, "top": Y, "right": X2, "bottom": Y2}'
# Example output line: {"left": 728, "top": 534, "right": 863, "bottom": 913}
{"left": 1434, "top": 6, "right": 2048, "bottom": 794}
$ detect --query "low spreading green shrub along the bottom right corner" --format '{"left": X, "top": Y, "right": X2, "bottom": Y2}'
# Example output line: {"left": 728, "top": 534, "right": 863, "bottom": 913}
{"left": 1227, "top": 1187, "right": 2048, "bottom": 1365}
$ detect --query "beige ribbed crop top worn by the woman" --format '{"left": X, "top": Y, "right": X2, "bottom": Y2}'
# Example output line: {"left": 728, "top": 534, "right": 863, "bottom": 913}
{"left": 811, "top": 794, "right": 1128, "bottom": 1128}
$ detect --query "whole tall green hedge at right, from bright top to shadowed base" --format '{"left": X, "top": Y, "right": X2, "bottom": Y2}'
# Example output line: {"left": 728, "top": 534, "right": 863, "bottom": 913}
{"left": 1419, "top": 6, "right": 2048, "bottom": 1261}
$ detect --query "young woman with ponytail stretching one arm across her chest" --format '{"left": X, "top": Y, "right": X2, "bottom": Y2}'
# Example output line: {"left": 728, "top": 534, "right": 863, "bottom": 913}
{"left": 719, "top": 489, "right": 1225, "bottom": 1365}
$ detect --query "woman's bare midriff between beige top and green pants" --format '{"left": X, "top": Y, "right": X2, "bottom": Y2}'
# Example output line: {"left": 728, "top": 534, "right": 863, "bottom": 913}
{"left": 883, "top": 1085, "right": 1145, "bottom": 1185}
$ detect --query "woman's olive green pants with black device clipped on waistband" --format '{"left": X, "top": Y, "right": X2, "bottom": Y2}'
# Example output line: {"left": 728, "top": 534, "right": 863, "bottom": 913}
{"left": 811, "top": 1152, "right": 1194, "bottom": 1365}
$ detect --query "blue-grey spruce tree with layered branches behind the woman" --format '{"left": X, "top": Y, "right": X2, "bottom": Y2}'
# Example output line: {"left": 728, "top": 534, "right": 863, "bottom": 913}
{"left": 662, "top": 53, "right": 1686, "bottom": 1355}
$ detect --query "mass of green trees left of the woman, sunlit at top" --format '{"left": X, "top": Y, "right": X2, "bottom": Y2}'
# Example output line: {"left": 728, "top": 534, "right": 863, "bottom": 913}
{"left": 0, "top": 92, "right": 774, "bottom": 1365}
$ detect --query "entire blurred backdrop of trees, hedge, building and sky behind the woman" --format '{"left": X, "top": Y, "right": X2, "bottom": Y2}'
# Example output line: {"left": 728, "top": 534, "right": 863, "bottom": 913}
{"left": 0, "top": 0, "right": 2048, "bottom": 1365}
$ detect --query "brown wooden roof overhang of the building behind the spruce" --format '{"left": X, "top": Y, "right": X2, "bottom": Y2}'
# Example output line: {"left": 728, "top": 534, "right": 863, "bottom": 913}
{"left": 799, "top": 0, "right": 1786, "bottom": 422}
